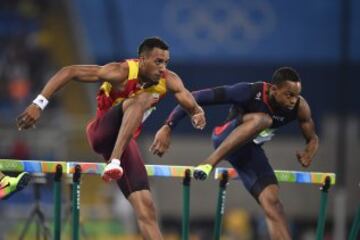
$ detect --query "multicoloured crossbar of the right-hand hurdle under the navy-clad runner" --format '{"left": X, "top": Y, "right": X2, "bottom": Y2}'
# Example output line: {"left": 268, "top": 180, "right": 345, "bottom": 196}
{"left": 215, "top": 168, "right": 336, "bottom": 185}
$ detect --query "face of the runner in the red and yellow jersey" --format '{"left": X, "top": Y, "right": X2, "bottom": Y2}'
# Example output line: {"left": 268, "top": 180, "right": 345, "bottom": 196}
{"left": 140, "top": 48, "right": 170, "bottom": 84}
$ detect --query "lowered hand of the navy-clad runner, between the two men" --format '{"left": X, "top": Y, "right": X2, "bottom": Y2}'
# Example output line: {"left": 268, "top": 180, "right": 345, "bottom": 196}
{"left": 149, "top": 124, "right": 171, "bottom": 157}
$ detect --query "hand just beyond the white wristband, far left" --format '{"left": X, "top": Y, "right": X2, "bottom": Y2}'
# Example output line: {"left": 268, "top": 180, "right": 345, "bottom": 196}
{"left": 16, "top": 103, "right": 41, "bottom": 131}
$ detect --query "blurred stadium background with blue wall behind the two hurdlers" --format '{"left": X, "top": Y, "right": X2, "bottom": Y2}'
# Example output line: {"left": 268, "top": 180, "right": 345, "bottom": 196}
{"left": 0, "top": 0, "right": 360, "bottom": 239}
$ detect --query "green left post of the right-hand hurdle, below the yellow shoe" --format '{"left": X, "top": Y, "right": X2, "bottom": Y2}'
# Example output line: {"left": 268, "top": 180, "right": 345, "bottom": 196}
{"left": 214, "top": 171, "right": 229, "bottom": 240}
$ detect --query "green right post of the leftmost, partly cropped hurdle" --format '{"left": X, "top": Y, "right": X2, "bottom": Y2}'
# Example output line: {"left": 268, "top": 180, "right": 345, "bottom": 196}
{"left": 54, "top": 164, "right": 63, "bottom": 240}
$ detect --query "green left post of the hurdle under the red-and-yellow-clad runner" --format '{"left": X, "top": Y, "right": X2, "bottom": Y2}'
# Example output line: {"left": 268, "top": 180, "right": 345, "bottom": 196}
{"left": 72, "top": 165, "right": 81, "bottom": 240}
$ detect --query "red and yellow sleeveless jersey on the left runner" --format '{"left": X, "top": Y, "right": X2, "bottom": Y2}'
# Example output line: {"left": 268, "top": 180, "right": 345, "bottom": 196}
{"left": 96, "top": 59, "right": 167, "bottom": 138}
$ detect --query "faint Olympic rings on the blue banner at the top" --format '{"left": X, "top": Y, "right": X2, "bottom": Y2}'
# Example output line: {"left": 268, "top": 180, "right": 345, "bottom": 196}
{"left": 163, "top": 0, "right": 276, "bottom": 54}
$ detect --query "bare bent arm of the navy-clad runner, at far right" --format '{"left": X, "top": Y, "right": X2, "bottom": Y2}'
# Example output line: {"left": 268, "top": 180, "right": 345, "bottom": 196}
{"left": 296, "top": 97, "right": 319, "bottom": 167}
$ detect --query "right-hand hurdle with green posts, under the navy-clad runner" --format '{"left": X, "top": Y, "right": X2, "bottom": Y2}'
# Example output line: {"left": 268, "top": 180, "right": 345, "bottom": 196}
{"left": 214, "top": 168, "right": 336, "bottom": 240}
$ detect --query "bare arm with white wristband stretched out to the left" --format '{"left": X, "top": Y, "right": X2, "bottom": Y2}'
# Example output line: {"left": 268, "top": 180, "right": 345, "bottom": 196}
{"left": 17, "top": 63, "right": 128, "bottom": 130}
